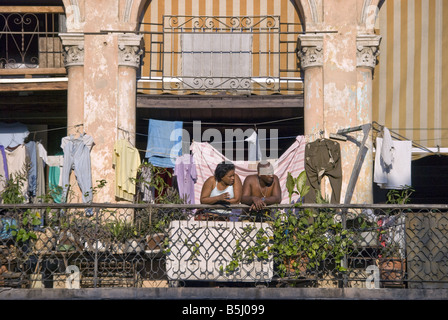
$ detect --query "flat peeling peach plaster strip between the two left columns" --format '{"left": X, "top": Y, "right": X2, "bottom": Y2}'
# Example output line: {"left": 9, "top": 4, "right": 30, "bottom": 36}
{"left": 84, "top": 35, "right": 118, "bottom": 202}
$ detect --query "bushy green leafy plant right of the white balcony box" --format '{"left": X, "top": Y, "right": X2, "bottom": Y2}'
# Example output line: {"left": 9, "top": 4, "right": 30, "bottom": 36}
{"left": 271, "top": 171, "right": 352, "bottom": 278}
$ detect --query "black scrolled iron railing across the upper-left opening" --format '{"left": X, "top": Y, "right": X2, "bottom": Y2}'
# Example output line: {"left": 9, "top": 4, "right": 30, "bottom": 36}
{"left": 0, "top": 7, "right": 64, "bottom": 70}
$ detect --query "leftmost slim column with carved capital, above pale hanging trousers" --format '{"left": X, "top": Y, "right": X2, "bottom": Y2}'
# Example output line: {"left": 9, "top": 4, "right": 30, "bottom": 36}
{"left": 59, "top": 33, "right": 84, "bottom": 134}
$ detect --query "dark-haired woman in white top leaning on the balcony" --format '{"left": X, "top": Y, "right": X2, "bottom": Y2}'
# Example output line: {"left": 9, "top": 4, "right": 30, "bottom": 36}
{"left": 198, "top": 161, "right": 243, "bottom": 220}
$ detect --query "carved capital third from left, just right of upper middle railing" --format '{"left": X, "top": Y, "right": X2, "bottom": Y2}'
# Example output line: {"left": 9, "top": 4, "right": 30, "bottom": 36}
{"left": 297, "top": 33, "right": 324, "bottom": 70}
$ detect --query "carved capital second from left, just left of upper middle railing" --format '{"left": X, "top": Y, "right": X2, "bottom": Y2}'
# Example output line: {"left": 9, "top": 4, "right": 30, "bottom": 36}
{"left": 118, "top": 33, "right": 143, "bottom": 68}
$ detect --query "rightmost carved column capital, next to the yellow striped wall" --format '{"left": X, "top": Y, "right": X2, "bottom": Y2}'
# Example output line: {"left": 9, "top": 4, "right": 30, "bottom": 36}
{"left": 356, "top": 34, "right": 381, "bottom": 69}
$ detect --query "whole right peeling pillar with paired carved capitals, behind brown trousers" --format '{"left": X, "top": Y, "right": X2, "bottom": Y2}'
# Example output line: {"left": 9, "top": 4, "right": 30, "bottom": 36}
{"left": 298, "top": 0, "right": 379, "bottom": 203}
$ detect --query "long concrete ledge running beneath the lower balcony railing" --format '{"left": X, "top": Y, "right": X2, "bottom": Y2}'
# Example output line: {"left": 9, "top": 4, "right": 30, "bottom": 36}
{"left": 0, "top": 287, "right": 448, "bottom": 300}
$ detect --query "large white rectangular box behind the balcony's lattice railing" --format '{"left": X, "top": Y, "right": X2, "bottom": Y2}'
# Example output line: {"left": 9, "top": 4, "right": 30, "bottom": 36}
{"left": 166, "top": 220, "right": 273, "bottom": 282}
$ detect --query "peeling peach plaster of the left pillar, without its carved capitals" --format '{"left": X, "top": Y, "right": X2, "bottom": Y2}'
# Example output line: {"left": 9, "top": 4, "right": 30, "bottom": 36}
{"left": 64, "top": 0, "right": 141, "bottom": 203}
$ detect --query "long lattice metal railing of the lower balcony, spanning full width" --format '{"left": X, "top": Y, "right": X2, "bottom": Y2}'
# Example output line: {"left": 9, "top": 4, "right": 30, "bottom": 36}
{"left": 0, "top": 204, "right": 448, "bottom": 288}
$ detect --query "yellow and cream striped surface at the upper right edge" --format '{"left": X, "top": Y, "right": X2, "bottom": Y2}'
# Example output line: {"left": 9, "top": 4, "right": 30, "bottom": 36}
{"left": 373, "top": 0, "right": 448, "bottom": 147}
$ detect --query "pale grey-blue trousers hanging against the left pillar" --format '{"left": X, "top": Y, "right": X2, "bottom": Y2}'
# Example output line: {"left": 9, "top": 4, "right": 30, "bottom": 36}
{"left": 61, "top": 133, "right": 93, "bottom": 205}
